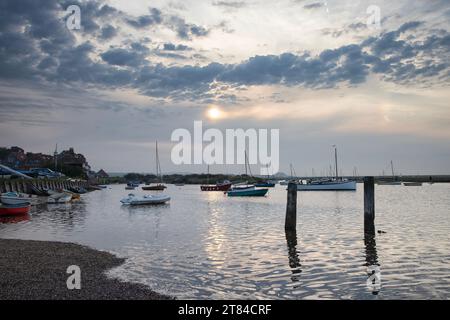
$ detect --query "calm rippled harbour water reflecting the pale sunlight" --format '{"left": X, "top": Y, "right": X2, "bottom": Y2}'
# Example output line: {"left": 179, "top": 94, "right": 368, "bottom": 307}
{"left": 0, "top": 184, "right": 450, "bottom": 299}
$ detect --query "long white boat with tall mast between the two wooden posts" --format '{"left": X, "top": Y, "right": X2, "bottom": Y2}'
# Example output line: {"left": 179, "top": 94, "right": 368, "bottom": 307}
{"left": 297, "top": 146, "right": 356, "bottom": 191}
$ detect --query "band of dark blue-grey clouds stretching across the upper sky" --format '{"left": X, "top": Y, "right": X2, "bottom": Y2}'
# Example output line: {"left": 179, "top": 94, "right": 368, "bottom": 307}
{"left": 0, "top": 1, "right": 450, "bottom": 101}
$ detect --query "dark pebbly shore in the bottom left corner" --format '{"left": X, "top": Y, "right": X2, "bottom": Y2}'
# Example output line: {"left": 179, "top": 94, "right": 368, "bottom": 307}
{"left": 0, "top": 239, "right": 174, "bottom": 300}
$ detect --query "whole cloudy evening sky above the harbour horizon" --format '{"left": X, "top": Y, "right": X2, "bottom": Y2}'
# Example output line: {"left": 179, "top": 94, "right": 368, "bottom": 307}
{"left": 0, "top": 0, "right": 450, "bottom": 175}
